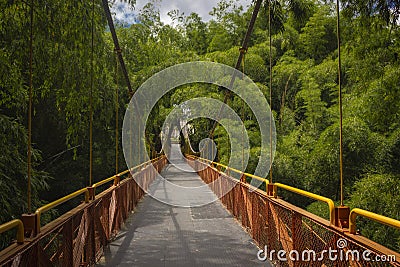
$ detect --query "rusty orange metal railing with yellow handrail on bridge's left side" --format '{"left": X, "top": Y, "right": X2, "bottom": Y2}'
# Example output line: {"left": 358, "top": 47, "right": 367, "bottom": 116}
{"left": 0, "top": 156, "right": 167, "bottom": 267}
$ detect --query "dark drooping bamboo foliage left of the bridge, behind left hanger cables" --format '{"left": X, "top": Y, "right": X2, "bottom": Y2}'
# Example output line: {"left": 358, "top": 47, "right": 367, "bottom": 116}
{"left": 0, "top": 1, "right": 119, "bottom": 249}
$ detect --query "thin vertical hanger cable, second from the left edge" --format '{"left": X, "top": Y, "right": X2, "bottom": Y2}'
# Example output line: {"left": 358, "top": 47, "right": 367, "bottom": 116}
{"left": 89, "top": 0, "right": 95, "bottom": 186}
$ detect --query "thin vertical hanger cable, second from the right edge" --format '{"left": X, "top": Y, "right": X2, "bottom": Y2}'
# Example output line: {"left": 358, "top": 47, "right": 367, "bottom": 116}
{"left": 268, "top": 0, "right": 273, "bottom": 183}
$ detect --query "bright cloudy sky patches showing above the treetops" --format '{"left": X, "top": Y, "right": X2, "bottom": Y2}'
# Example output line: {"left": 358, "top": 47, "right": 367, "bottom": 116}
{"left": 113, "top": 0, "right": 251, "bottom": 24}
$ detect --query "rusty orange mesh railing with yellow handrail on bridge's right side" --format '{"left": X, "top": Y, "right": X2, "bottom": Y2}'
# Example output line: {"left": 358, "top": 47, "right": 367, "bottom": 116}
{"left": 187, "top": 156, "right": 400, "bottom": 267}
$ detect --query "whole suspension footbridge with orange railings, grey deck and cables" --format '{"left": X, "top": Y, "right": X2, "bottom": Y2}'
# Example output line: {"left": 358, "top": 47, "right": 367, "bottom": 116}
{"left": 0, "top": 0, "right": 400, "bottom": 267}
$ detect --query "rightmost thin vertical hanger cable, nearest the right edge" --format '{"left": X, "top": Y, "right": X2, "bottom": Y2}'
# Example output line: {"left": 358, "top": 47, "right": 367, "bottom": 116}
{"left": 336, "top": 0, "right": 344, "bottom": 206}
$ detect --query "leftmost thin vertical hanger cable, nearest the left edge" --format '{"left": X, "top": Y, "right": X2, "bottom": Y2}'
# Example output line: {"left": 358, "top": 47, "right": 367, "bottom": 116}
{"left": 27, "top": 0, "right": 34, "bottom": 213}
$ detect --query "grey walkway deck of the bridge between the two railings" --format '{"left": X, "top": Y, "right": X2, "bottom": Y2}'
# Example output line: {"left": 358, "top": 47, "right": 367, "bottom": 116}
{"left": 99, "top": 147, "right": 271, "bottom": 267}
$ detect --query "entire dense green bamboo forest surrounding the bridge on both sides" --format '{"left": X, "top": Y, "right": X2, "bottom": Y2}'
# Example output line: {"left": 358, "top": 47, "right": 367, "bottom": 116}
{"left": 0, "top": 0, "right": 400, "bottom": 253}
